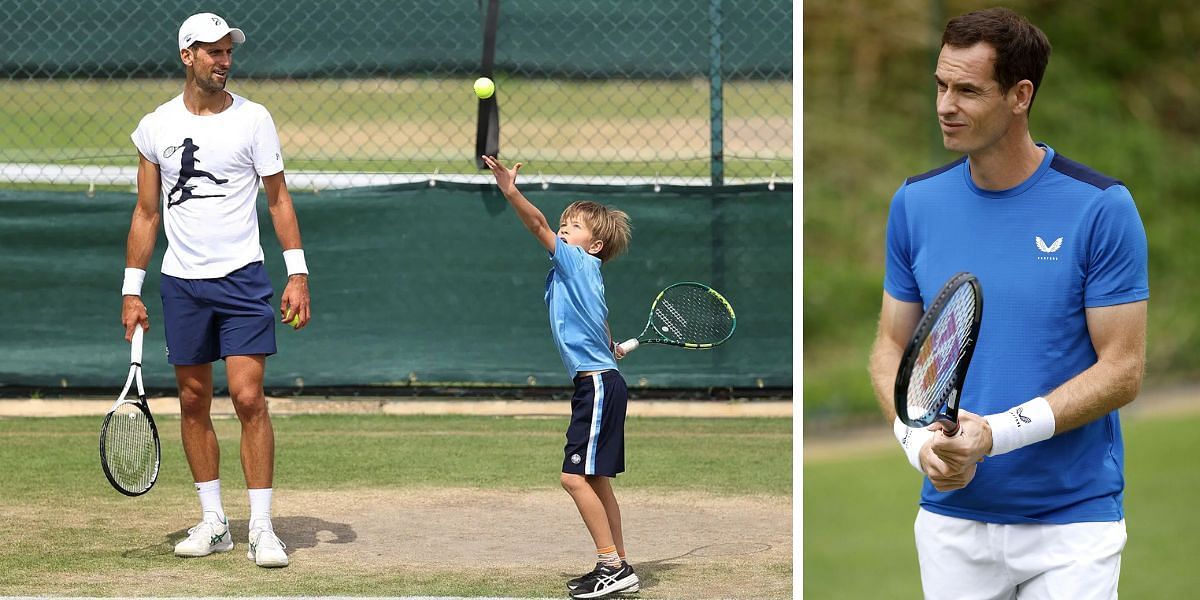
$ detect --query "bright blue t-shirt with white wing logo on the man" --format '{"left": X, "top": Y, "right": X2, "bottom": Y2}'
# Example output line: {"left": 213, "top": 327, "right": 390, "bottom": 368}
{"left": 883, "top": 144, "right": 1150, "bottom": 523}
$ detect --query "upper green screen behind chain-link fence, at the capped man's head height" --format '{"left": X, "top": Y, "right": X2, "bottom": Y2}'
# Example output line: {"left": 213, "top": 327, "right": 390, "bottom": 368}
{"left": 0, "top": 0, "right": 792, "bottom": 79}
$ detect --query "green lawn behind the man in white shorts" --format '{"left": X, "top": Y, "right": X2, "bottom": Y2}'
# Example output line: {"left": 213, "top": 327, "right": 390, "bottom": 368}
{"left": 804, "top": 415, "right": 1200, "bottom": 599}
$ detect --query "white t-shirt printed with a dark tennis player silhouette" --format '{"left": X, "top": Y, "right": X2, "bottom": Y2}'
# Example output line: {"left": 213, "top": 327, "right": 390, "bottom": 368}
{"left": 131, "top": 94, "right": 283, "bottom": 280}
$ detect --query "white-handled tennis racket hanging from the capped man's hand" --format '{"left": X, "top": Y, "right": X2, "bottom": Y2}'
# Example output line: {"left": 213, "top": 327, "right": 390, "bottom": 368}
{"left": 100, "top": 325, "right": 162, "bottom": 496}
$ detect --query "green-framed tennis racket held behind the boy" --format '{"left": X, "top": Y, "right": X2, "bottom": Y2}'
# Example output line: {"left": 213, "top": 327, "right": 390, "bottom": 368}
{"left": 620, "top": 281, "right": 737, "bottom": 354}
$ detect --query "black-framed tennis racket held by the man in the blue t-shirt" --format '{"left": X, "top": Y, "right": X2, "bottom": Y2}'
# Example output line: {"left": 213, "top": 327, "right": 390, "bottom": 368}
{"left": 895, "top": 272, "right": 983, "bottom": 436}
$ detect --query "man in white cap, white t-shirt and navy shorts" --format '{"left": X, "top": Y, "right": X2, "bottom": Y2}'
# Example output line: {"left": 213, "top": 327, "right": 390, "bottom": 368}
{"left": 121, "top": 13, "right": 311, "bottom": 566}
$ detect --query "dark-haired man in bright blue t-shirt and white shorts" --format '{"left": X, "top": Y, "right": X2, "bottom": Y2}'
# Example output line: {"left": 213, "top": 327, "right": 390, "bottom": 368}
{"left": 870, "top": 8, "right": 1150, "bottom": 599}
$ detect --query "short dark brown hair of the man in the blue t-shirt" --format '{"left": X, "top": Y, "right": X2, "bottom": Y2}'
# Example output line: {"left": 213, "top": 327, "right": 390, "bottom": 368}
{"left": 942, "top": 8, "right": 1050, "bottom": 109}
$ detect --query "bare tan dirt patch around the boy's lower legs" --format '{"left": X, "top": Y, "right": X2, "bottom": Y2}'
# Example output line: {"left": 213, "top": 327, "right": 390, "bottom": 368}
{"left": 283, "top": 490, "right": 792, "bottom": 599}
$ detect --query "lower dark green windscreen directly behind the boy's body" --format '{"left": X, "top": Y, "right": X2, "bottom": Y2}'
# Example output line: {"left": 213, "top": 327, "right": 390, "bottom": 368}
{"left": 0, "top": 187, "right": 792, "bottom": 394}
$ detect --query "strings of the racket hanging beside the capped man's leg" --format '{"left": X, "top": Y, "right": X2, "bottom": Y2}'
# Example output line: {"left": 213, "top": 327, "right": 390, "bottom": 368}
{"left": 104, "top": 402, "right": 155, "bottom": 492}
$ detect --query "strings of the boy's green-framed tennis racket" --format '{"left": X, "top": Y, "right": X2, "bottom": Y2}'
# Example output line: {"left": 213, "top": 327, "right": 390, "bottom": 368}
{"left": 654, "top": 286, "right": 733, "bottom": 343}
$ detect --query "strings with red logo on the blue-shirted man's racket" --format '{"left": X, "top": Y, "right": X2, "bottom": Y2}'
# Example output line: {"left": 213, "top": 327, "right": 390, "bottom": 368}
{"left": 907, "top": 286, "right": 976, "bottom": 415}
